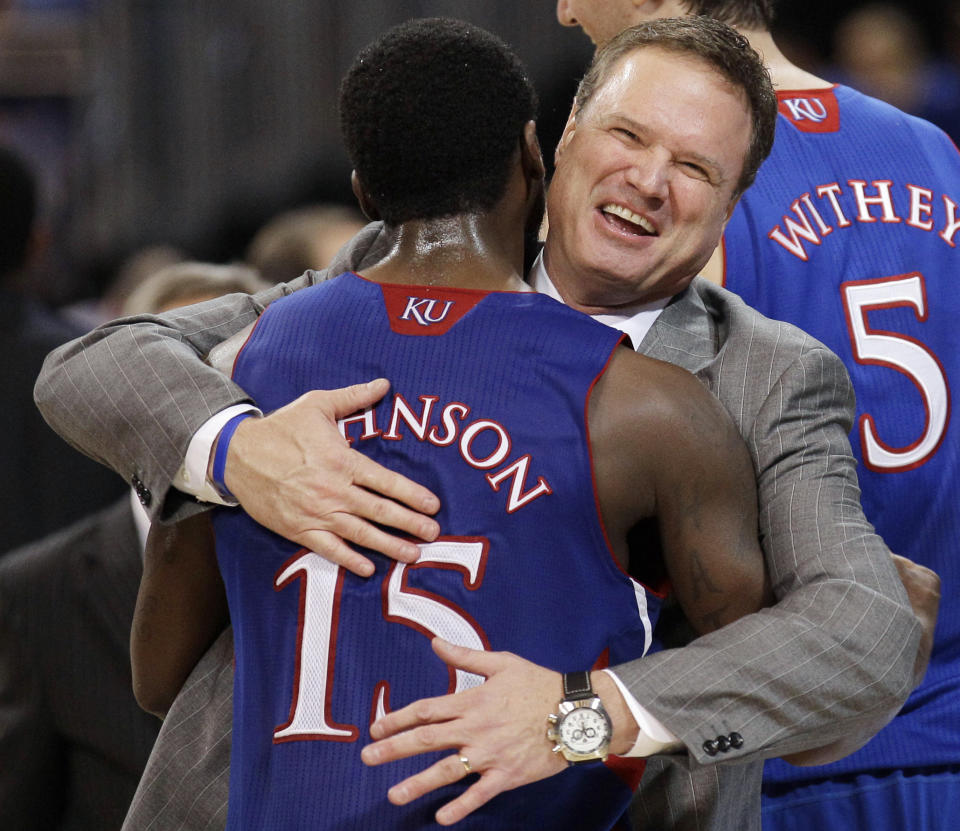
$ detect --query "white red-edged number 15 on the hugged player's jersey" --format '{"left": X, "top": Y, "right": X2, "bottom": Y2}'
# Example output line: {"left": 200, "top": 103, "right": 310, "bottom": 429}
{"left": 273, "top": 538, "right": 489, "bottom": 742}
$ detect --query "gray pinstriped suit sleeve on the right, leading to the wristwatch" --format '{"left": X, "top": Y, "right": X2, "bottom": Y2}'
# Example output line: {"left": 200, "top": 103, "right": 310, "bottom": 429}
{"left": 615, "top": 347, "right": 920, "bottom": 765}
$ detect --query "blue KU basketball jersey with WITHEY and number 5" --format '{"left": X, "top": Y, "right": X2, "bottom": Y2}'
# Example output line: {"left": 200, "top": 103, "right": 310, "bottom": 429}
{"left": 723, "top": 86, "right": 960, "bottom": 782}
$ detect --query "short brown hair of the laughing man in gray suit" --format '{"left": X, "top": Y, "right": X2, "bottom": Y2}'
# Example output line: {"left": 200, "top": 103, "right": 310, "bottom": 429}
{"left": 576, "top": 16, "right": 777, "bottom": 195}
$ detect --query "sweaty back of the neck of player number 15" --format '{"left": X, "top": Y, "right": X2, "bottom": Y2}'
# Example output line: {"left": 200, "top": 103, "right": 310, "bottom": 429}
{"left": 363, "top": 214, "right": 529, "bottom": 291}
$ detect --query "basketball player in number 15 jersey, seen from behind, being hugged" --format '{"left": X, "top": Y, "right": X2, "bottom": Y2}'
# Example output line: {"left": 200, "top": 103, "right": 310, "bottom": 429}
{"left": 134, "top": 20, "right": 767, "bottom": 829}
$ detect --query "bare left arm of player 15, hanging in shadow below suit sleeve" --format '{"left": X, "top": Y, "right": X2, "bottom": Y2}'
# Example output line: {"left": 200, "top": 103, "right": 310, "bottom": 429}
{"left": 130, "top": 513, "right": 229, "bottom": 717}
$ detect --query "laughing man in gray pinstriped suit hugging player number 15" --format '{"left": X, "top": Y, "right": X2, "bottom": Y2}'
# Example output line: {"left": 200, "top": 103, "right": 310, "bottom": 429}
{"left": 37, "top": 14, "right": 919, "bottom": 828}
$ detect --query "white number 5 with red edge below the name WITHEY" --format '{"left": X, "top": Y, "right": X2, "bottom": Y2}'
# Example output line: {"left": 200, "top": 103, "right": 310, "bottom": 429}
{"left": 840, "top": 272, "right": 950, "bottom": 473}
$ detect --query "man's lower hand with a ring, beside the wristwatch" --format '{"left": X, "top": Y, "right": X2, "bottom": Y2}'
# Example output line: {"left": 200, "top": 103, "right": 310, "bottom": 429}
{"left": 362, "top": 638, "right": 567, "bottom": 825}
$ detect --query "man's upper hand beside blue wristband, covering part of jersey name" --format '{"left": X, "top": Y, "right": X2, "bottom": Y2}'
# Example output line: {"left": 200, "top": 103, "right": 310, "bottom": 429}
{"left": 224, "top": 378, "right": 440, "bottom": 577}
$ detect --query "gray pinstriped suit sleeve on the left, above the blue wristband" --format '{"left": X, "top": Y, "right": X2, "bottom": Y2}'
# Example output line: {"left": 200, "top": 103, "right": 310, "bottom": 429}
{"left": 34, "top": 225, "right": 386, "bottom": 520}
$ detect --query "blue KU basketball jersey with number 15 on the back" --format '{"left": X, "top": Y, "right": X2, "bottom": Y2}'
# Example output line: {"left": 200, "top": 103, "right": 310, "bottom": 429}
{"left": 215, "top": 273, "right": 659, "bottom": 831}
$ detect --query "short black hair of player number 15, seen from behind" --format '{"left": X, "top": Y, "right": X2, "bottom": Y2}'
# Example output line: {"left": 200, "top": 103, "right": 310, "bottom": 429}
{"left": 340, "top": 18, "right": 537, "bottom": 225}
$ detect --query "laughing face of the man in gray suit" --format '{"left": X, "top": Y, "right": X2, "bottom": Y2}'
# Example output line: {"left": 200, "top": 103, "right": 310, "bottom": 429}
{"left": 545, "top": 47, "right": 751, "bottom": 312}
